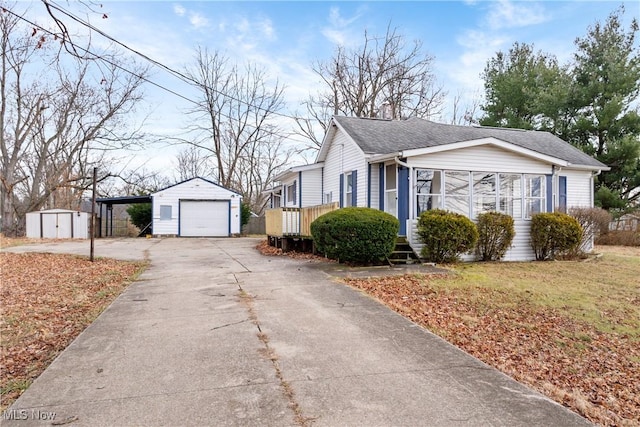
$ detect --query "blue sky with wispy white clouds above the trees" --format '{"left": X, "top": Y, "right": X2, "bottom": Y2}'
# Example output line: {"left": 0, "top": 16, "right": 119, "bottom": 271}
{"left": 15, "top": 0, "right": 640, "bottom": 172}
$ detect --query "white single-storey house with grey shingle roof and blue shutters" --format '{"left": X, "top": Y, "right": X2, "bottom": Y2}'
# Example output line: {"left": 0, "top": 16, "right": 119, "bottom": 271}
{"left": 268, "top": 116, "right": 609, "bottom": 260}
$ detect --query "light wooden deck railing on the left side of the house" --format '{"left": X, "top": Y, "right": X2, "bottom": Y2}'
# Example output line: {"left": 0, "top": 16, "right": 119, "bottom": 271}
{"left": 265, "top": 203, "right": 339, "bottom": 237}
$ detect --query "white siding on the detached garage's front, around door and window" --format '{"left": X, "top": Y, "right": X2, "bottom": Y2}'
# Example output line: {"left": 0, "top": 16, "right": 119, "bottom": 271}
{"left": 152, "top": 178, "right": 241, "bottom": 236}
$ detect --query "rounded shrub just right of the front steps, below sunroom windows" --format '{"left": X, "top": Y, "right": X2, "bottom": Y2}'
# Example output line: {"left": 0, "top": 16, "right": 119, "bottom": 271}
{"left": 418, "top": 209, "right": 478, "bottom": 263}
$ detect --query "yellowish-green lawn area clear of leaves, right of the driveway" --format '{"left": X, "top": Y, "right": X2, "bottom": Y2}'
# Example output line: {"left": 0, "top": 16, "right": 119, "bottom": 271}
{"left": 430, "top": 247, "right": 640, "bottom": 340}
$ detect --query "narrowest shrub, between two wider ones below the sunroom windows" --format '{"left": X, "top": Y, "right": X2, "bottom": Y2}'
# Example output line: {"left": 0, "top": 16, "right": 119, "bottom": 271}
{"left": 476, "top": 212, "right": 516, "bottom": 261}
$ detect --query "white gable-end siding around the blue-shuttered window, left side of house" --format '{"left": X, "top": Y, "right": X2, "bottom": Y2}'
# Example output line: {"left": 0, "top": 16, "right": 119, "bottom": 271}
{"left": 323, "top": 130, "right": 367, "bottom": 206}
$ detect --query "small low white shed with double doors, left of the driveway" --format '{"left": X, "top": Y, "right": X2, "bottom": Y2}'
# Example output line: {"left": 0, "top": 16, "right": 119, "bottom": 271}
{"left": 27, "top": 209, "right": 89, "bottom": 239}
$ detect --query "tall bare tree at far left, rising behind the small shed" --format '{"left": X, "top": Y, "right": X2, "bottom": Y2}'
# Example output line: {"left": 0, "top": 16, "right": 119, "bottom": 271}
{"left": 0, "top": 6, "right": 146, "bottom": 234}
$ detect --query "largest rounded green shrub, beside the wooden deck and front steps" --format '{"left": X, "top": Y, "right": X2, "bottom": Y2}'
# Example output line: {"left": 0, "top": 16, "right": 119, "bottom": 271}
{"left": 311, "top": 207, "right": 400, "bottom": 264}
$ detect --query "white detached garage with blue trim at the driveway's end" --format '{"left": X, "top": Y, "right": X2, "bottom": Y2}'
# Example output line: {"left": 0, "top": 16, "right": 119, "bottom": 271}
{"left": 151, "top": 178, "right": 242, "bottom": 237}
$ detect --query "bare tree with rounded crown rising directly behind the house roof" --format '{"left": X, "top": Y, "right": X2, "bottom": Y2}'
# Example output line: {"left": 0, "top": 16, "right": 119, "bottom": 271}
{"left": 297, "top": 27, "right": 445, "bottom": 150}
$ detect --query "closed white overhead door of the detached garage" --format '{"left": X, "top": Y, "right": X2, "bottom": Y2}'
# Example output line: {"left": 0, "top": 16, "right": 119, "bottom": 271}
{"left": 180, "top": 200, "right": 229, "bottom": 237}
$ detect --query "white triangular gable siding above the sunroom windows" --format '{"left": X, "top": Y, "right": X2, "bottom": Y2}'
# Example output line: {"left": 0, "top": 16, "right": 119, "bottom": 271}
{"left": 407, "top": 145, "right": 551, "bottom": 174}
